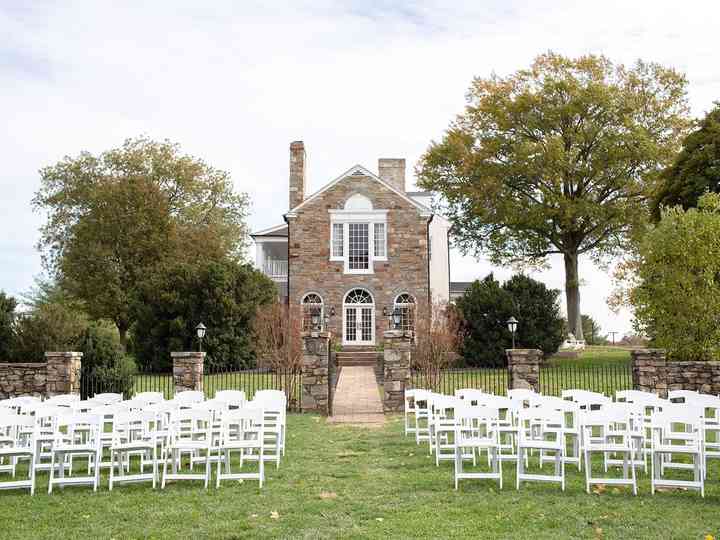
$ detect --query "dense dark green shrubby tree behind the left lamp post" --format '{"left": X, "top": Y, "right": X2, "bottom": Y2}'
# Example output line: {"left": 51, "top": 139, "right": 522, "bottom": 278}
{"left": 131, "top": 258, "right": 277, "bottom": 370}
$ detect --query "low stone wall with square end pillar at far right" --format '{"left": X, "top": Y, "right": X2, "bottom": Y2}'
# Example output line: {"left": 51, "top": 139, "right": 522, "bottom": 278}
{"left": 630, "top": 349, "right": 720, "bottom": 398}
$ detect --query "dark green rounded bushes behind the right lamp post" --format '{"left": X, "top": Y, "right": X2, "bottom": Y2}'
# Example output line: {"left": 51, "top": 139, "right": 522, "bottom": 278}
{"left": 456, "top": 274, "right": 563, "bottom": 367}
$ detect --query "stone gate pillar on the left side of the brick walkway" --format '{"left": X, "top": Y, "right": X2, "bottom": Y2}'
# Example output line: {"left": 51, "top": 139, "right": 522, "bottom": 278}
{"left": 300, "top": 332, "right": 331, "bottom": 416}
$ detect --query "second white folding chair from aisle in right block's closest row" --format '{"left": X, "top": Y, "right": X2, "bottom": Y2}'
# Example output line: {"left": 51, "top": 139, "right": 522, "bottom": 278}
{"left": 516, "top": 407, "right": 565, "bottom": 491}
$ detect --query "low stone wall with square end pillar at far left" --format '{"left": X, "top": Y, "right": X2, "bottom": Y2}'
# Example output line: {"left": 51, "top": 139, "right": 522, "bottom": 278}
{"left": 0, "top": 352, "right": 82, "bottom": 399}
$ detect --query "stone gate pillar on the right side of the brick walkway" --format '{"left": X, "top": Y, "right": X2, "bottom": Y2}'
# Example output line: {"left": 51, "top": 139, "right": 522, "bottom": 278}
{"left": 383, "top": 330, "right": 413, "bottom": 412}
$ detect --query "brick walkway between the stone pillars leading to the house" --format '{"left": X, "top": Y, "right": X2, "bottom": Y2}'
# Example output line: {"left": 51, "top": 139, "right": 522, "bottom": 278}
{"left": 328, "top": 366, "right": 385, "bottom": 424}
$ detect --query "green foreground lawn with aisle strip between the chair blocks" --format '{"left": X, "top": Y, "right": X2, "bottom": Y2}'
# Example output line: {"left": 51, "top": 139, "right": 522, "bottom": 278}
{"left": 0, "top": 415, "right": 720, "bottom": 540}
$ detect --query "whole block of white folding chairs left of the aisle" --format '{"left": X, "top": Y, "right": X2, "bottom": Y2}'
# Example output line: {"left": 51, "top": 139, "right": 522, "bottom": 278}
{"left": 0, "top": 390, "right": 287, "bottom": 494}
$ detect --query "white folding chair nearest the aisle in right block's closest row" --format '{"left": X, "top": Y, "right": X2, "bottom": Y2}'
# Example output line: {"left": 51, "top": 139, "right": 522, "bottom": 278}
{"left": 455, "top": 405, "right": 502, "bottom": 489}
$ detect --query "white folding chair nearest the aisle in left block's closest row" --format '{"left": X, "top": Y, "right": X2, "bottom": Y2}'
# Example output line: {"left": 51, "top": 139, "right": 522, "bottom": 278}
{"left": 215, "top": 408, "right": 265, "bottom": 488}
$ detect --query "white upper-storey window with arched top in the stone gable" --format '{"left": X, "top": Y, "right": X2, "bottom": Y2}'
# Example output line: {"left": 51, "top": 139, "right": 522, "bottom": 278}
{"left": 329, "top": 193, "right": 387, "bottom": 274}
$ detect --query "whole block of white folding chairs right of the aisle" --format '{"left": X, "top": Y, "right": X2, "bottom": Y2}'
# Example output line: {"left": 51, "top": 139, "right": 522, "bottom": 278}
{"left": 405, "top": 389, "right": 720, "bottom": 496}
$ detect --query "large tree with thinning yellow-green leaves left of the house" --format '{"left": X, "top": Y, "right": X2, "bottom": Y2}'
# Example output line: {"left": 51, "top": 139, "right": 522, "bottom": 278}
{"left": 33, "top": 138, "right": 248, "bottom": 347}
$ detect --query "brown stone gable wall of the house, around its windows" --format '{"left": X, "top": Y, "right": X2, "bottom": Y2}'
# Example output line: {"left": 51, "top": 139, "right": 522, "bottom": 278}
{"left": 287, "top": 174, "right": 430, "bottom": 344}
